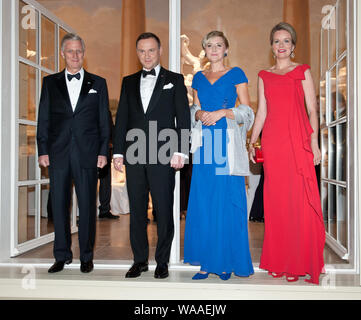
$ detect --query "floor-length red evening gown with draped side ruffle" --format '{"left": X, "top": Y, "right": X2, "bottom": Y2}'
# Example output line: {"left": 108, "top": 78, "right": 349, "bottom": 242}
{"left": 259, "top": 65, "right": 325, "bottom": 284}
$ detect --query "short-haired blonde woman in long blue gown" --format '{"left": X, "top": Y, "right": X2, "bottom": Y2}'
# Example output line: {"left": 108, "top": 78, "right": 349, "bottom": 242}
{"left": 184, "top": 31, "right": 253, "bottom": 280}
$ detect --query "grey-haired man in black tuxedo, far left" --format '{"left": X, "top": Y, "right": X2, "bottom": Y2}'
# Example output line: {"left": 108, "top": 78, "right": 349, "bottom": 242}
{"left": 37, "top": 34, "right": 110, "bottom": 273}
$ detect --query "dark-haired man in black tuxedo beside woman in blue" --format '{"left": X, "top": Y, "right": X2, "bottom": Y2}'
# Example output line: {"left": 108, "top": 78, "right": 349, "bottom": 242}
{"left": 113, "top": 33, "right": 190, "bottom": 278}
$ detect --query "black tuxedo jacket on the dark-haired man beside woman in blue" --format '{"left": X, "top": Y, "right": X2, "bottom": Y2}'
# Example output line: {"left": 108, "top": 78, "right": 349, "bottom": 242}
{"left": 113, "top": 67, "right": 190, "bottom": 164}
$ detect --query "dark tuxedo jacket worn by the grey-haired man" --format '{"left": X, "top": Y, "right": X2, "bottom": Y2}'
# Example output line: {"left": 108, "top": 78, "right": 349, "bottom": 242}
{"left": 37, "top": 70, "right": 110, "bottom": 168}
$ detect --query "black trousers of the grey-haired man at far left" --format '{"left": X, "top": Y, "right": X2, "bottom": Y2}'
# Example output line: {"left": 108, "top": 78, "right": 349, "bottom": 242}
{"left": 49, "top": 141, "right": 98, "bottom": 262}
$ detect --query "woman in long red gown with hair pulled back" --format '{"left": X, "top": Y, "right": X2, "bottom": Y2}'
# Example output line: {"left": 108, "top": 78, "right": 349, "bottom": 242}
{"left": 249, "top": 22, "right": 325, "bottom": 284}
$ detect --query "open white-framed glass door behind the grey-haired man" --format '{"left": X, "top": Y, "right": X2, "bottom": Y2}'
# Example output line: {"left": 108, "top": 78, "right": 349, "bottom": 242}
{"left": 14, "top": 0, "right": 77, "bottom": 253}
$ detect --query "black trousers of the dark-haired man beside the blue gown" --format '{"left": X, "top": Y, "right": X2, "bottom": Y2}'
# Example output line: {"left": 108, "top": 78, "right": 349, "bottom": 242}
{"left": 126, "top": 164, "right": 175, "bottom": 263}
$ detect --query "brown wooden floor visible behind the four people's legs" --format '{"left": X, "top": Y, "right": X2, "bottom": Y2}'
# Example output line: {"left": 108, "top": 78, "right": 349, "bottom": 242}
{"left": 16, "top": 214, "right": 346, "bottom": 264}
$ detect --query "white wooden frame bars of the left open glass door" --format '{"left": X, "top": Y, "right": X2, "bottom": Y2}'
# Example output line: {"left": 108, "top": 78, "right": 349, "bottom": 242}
{"left": 10, "top": 0, "right": 77, "bottom": 257}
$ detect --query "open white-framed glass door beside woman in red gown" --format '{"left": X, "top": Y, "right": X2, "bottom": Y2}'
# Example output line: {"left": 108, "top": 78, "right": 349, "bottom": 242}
{"left": 320, "top": 0, "right": 351, "bottom": 259}
